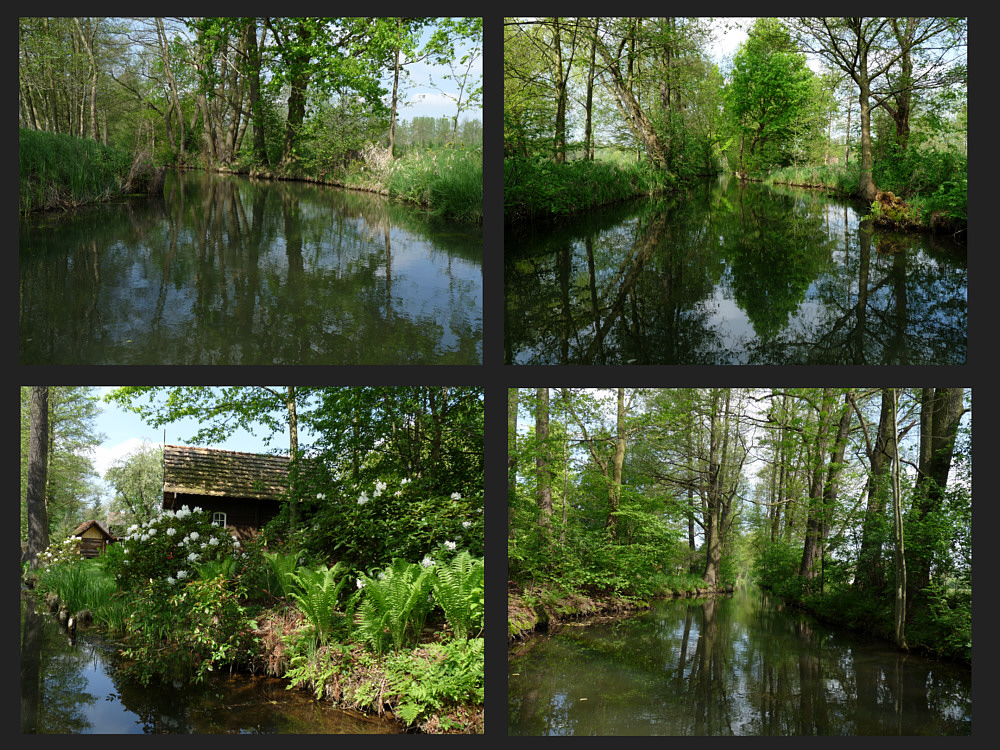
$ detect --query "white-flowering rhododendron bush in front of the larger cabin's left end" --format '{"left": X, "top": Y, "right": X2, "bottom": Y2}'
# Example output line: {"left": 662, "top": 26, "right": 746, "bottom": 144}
{"left": 108, "top": 505, "right": 241, "bottom": 588}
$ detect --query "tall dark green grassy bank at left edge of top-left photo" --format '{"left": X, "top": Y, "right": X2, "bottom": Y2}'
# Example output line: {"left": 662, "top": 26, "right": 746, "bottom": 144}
{"left": 18, "top": 128, "right": 162, "bottom": 214}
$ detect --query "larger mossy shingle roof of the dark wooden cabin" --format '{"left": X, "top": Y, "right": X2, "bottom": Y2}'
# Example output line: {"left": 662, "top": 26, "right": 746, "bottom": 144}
{"left": 163, "top": 445, "right": 288, "bottom": 500}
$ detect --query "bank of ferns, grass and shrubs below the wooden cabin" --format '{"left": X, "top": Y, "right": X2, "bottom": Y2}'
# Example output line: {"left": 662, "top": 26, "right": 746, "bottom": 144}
{"left": 29, "top": 519, "right": 484, "bottom": 733}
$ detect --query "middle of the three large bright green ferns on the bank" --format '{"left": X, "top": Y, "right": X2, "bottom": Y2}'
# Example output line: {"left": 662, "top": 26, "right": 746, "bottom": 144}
{"left": 356, "top": 557, "right": 434, "bottom": 653}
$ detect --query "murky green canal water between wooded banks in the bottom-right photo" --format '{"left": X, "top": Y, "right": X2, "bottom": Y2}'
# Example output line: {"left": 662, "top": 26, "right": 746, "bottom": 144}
{"left": 508, "top": 588, "right": 972, "bottom": 736}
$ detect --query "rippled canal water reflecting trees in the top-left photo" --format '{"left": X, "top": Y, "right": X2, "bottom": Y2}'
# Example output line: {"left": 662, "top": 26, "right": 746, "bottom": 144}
{"left": 18, "top": 171, "right": 483, "bottom": 365}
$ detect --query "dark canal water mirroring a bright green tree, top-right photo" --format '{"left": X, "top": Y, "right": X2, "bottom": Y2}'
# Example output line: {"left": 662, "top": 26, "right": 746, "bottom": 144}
{"left": 504, "top": 176, "right": 968, "bottom": 365}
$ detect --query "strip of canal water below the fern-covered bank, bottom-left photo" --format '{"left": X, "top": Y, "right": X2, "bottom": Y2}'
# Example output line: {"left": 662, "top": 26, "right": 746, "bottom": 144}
{"left": 21, "top": 596, "right": 400, "bottom": 734}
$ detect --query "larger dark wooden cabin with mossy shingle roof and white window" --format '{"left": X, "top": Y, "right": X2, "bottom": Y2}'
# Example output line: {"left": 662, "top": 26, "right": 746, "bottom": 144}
{"left": 163, "top": 445, "right": 288, "bottom": 539}
